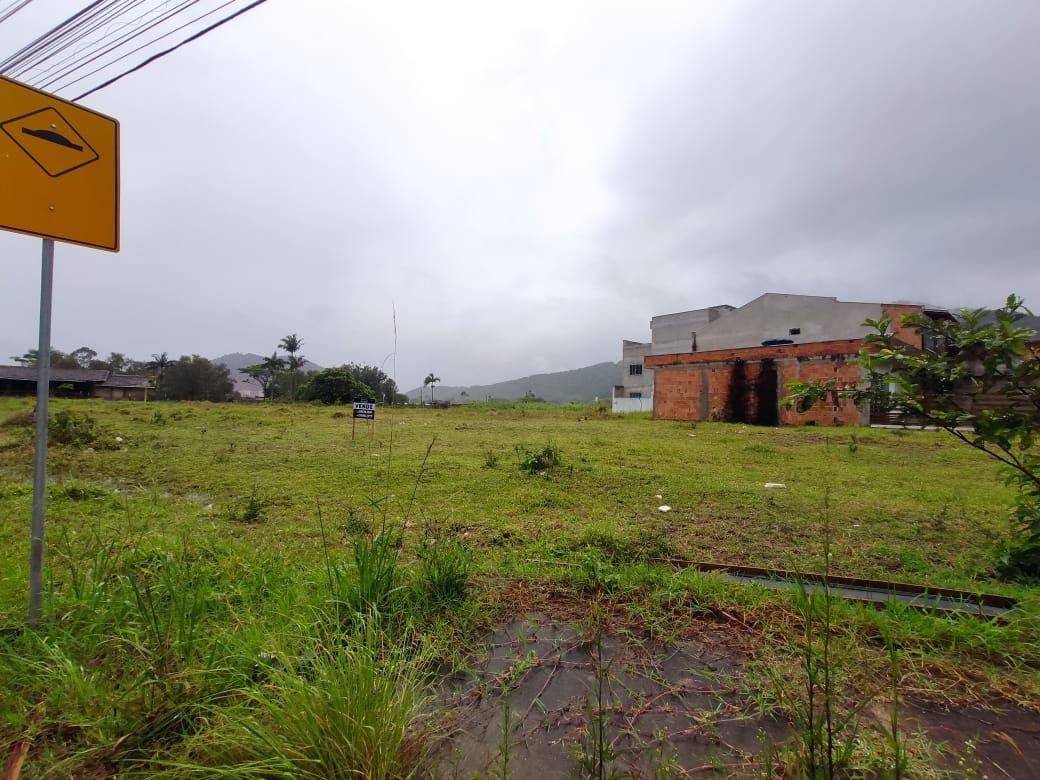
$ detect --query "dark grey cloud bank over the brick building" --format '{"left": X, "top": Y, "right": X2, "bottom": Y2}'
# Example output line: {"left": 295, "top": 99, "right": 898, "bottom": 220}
{"left": 609, "top": 3, "right": 1040, "bottom": 316}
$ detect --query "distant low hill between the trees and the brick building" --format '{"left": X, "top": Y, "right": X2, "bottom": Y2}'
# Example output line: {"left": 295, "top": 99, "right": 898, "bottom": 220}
{"left": 407, "top": 363, "right": 621, "bottom": 404}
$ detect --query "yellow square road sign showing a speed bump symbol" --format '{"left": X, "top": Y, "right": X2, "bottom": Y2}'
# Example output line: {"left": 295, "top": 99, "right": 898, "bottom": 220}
{"left": 0, "top": 76, "right": 120, "bottom": 251}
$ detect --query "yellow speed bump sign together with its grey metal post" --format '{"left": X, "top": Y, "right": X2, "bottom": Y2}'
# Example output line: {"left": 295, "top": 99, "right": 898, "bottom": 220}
{"left": 0, "top": 76, "right": 120, "bottom": 623}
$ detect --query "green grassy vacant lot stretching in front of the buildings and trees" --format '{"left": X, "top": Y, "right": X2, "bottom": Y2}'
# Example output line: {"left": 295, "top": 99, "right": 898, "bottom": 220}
{"left": 0, "top": 399, "right": 1040, "bottom": 777}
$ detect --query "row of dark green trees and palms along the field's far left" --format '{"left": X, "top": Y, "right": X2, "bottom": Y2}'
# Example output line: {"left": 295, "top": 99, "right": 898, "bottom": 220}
{"left": 11, "top": 333, "right": 408, "bottom": 405}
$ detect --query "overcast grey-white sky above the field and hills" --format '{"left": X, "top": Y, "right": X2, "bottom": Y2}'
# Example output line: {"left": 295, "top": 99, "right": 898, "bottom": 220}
{"left": 0, "top": 0, "right": 1040, "bottom": 389}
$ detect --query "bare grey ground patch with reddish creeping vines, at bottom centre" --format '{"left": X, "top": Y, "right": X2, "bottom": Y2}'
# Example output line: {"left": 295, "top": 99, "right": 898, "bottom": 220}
{"left": 440, "top": 613, "right": 787, "bottom": 780}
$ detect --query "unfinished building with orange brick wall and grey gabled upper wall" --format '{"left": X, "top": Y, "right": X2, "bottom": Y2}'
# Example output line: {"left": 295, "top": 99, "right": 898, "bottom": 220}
{"left": 624, "top": 293, "right": 951, "bottom": 425}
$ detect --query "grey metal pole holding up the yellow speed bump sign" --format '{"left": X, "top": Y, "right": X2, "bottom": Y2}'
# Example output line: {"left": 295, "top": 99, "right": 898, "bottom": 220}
{"left": 29, "top": 238, "right": 54, "bottom": 623}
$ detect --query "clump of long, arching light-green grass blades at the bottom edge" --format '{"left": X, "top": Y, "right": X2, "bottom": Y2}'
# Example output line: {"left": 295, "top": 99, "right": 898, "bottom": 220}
{"left": 165, "top": 618, "right": 430, "bottom": 779}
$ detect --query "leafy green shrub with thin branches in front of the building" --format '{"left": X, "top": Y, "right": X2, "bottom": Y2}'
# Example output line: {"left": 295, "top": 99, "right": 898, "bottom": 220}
{"left": 784, "top": 295, "right": 1040, "bottom": 580}
